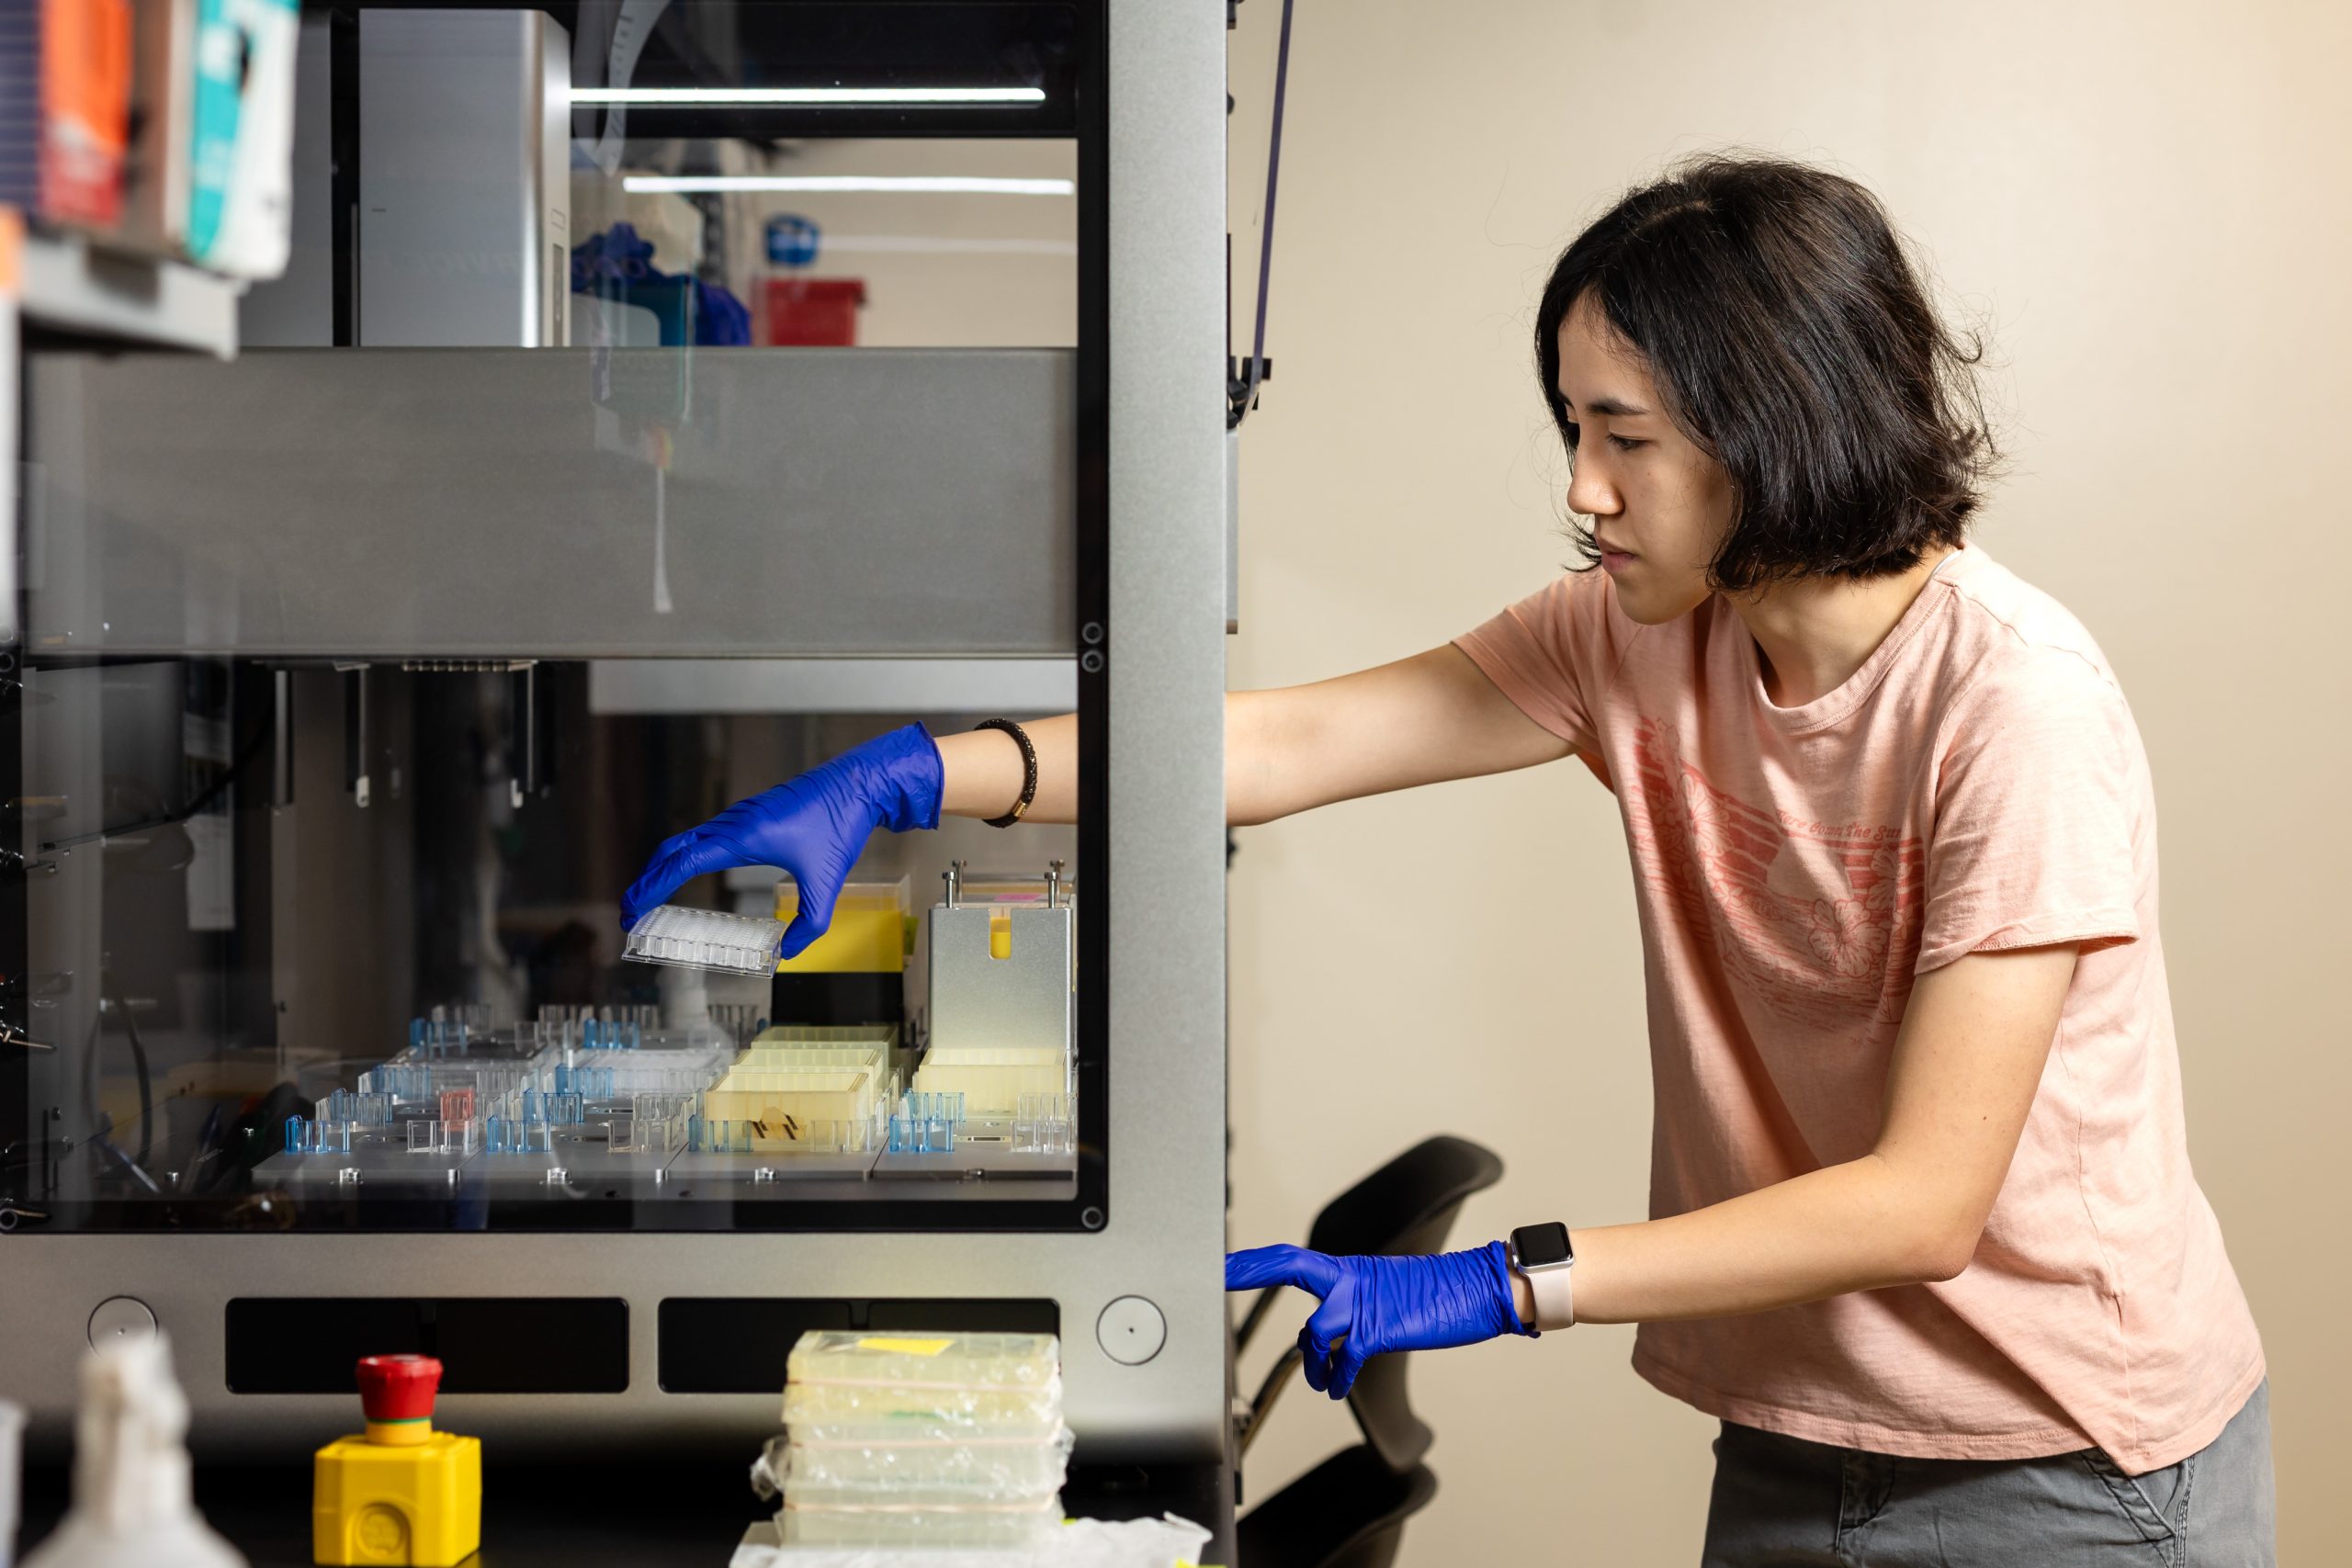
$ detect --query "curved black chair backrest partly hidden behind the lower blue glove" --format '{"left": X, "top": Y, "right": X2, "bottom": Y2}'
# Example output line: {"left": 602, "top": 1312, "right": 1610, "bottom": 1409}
{"left": 1307, "top": 1135, "right": 1503, "bottom": 1474}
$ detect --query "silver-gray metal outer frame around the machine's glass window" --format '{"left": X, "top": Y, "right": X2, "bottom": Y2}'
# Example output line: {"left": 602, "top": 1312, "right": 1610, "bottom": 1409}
{"left": 0, "top": 0, "right": 1227, "bottom": 1460}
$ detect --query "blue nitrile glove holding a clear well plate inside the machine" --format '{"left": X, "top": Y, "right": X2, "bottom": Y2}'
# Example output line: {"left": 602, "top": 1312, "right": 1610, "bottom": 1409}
{"left": 621, "top": 724, "right": 944, "bottom": 957}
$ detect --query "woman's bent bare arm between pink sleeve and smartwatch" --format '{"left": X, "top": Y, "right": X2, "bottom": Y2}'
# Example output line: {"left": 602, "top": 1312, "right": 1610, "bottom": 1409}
{"left": 1561, "top": 945, "right": 2075, "bottom": 1324}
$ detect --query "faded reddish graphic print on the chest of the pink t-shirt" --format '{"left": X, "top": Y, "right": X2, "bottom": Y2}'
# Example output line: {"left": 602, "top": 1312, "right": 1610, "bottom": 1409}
{"left": 1625, "top": 717, "right": 1927, "bottom": 1037}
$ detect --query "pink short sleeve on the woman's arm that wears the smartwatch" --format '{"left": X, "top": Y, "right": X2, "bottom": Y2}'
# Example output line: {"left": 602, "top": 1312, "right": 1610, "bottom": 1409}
{"left": 1915, "top": 649, "right": 2152, "bottom": 974}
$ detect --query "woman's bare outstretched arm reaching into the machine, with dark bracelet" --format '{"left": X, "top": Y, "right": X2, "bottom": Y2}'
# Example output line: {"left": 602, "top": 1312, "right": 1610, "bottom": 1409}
{"left": 938, "top": 644, "right": 1571, "bottom": 825}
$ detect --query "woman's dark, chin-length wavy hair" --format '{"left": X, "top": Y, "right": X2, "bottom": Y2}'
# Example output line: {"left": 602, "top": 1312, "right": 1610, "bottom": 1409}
{"left": 1536, "top": 155, "right": 1995, "bottom": 592}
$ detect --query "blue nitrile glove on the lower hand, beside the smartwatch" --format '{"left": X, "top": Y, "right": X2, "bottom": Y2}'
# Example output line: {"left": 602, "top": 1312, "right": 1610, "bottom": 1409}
{"left": 1226, "top": 1241, "right": 1536, "bottom": 1399}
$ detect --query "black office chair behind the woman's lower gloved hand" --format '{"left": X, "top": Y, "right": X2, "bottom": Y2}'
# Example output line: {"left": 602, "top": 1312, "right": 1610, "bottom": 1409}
{"left": 1235, "top": 1138, "right": 1503, "bottom": 1568}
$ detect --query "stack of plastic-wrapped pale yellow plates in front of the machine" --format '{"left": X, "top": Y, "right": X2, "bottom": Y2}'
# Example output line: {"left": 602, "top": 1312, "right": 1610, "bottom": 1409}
{"left": 752, "top": 1331, "right": 1070, "bottom": 1547}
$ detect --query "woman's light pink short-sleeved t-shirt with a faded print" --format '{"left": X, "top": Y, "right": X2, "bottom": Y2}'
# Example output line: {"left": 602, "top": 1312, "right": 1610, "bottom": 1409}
{"left": 1461, "top": 547, "right": 2263, "bottom": 1474}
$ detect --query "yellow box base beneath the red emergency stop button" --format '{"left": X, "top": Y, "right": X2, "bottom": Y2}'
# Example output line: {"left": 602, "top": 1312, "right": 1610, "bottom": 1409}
{"left": 311, "top": 1422, "right": 482, "bottom": 1568}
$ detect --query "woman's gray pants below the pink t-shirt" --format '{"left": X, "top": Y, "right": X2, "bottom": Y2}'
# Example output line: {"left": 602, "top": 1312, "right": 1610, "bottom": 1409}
{"left": 1701, "top": 1382, "right": 2277, "bottom": 1568}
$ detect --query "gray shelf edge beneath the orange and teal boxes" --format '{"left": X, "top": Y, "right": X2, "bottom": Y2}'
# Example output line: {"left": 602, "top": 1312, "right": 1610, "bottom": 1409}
{"left": 18, "top": 231, "right": 244, "bottom": 360}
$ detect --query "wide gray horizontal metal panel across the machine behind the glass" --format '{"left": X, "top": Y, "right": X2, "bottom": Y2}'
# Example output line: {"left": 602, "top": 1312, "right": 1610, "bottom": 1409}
{"left": 24, "top": 348, "right": 1080, "bottom": 658}
